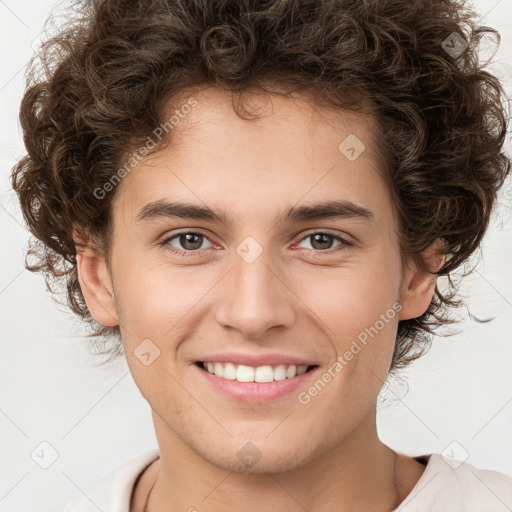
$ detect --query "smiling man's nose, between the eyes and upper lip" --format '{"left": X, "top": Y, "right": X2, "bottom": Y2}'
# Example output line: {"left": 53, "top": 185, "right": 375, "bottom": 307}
{"left": 216, "top": 251, "right": 297, "bottom": 339}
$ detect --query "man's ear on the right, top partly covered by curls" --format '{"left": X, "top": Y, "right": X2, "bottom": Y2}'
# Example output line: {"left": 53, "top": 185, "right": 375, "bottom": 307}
{"left": 398, "top": 238, "right": 445, "bottom": 320}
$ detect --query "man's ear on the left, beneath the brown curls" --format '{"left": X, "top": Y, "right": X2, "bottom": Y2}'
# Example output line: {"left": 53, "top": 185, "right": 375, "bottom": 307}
{"left": 73, "top": 230, "right": 119, "bottom": 327}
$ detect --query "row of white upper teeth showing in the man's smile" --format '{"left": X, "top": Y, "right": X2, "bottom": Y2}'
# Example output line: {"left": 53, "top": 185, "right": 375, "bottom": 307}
{"left": 202, "top": 362, "right": 308, "bottom": 382}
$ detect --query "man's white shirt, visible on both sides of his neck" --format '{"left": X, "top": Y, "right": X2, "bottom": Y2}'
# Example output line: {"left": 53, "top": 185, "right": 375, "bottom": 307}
{"left": 63, "top": 449, "right": 512, "bottom": 512}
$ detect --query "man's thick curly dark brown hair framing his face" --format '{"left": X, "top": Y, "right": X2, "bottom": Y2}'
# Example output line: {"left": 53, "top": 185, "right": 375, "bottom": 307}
{"left": 12, "top": 0, "right": 510, "bottom": 371}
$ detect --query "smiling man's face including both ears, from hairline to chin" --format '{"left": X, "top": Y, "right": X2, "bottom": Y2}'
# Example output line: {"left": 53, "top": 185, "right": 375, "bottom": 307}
{"left": 79, "top": 88, "right": 433, "bottom": 472}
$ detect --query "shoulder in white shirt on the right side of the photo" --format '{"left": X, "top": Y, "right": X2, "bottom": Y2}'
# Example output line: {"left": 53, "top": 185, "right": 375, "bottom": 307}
{"left": 395, "top": 453, "right": 512, "bottom": 512}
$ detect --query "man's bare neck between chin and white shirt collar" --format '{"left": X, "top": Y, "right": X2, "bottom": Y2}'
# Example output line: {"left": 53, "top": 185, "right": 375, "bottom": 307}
{"left": 141, "top": 409, "right": 414, "bottom": 512}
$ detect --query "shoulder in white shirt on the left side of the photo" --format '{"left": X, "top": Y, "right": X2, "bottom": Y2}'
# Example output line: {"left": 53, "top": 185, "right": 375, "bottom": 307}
{"left": 63, "top": 449, "right": 160, "bottom": 512}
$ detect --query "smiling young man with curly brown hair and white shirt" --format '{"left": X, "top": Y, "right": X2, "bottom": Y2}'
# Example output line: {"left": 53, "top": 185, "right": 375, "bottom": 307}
{"left": 13, "top": 0, "right": 512, "bottom": 512}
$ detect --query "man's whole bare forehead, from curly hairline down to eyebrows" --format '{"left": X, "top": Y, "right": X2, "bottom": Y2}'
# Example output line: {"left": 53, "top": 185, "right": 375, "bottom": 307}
{"left": 111, "top": 87, "right": 389, "bottom": 227}
